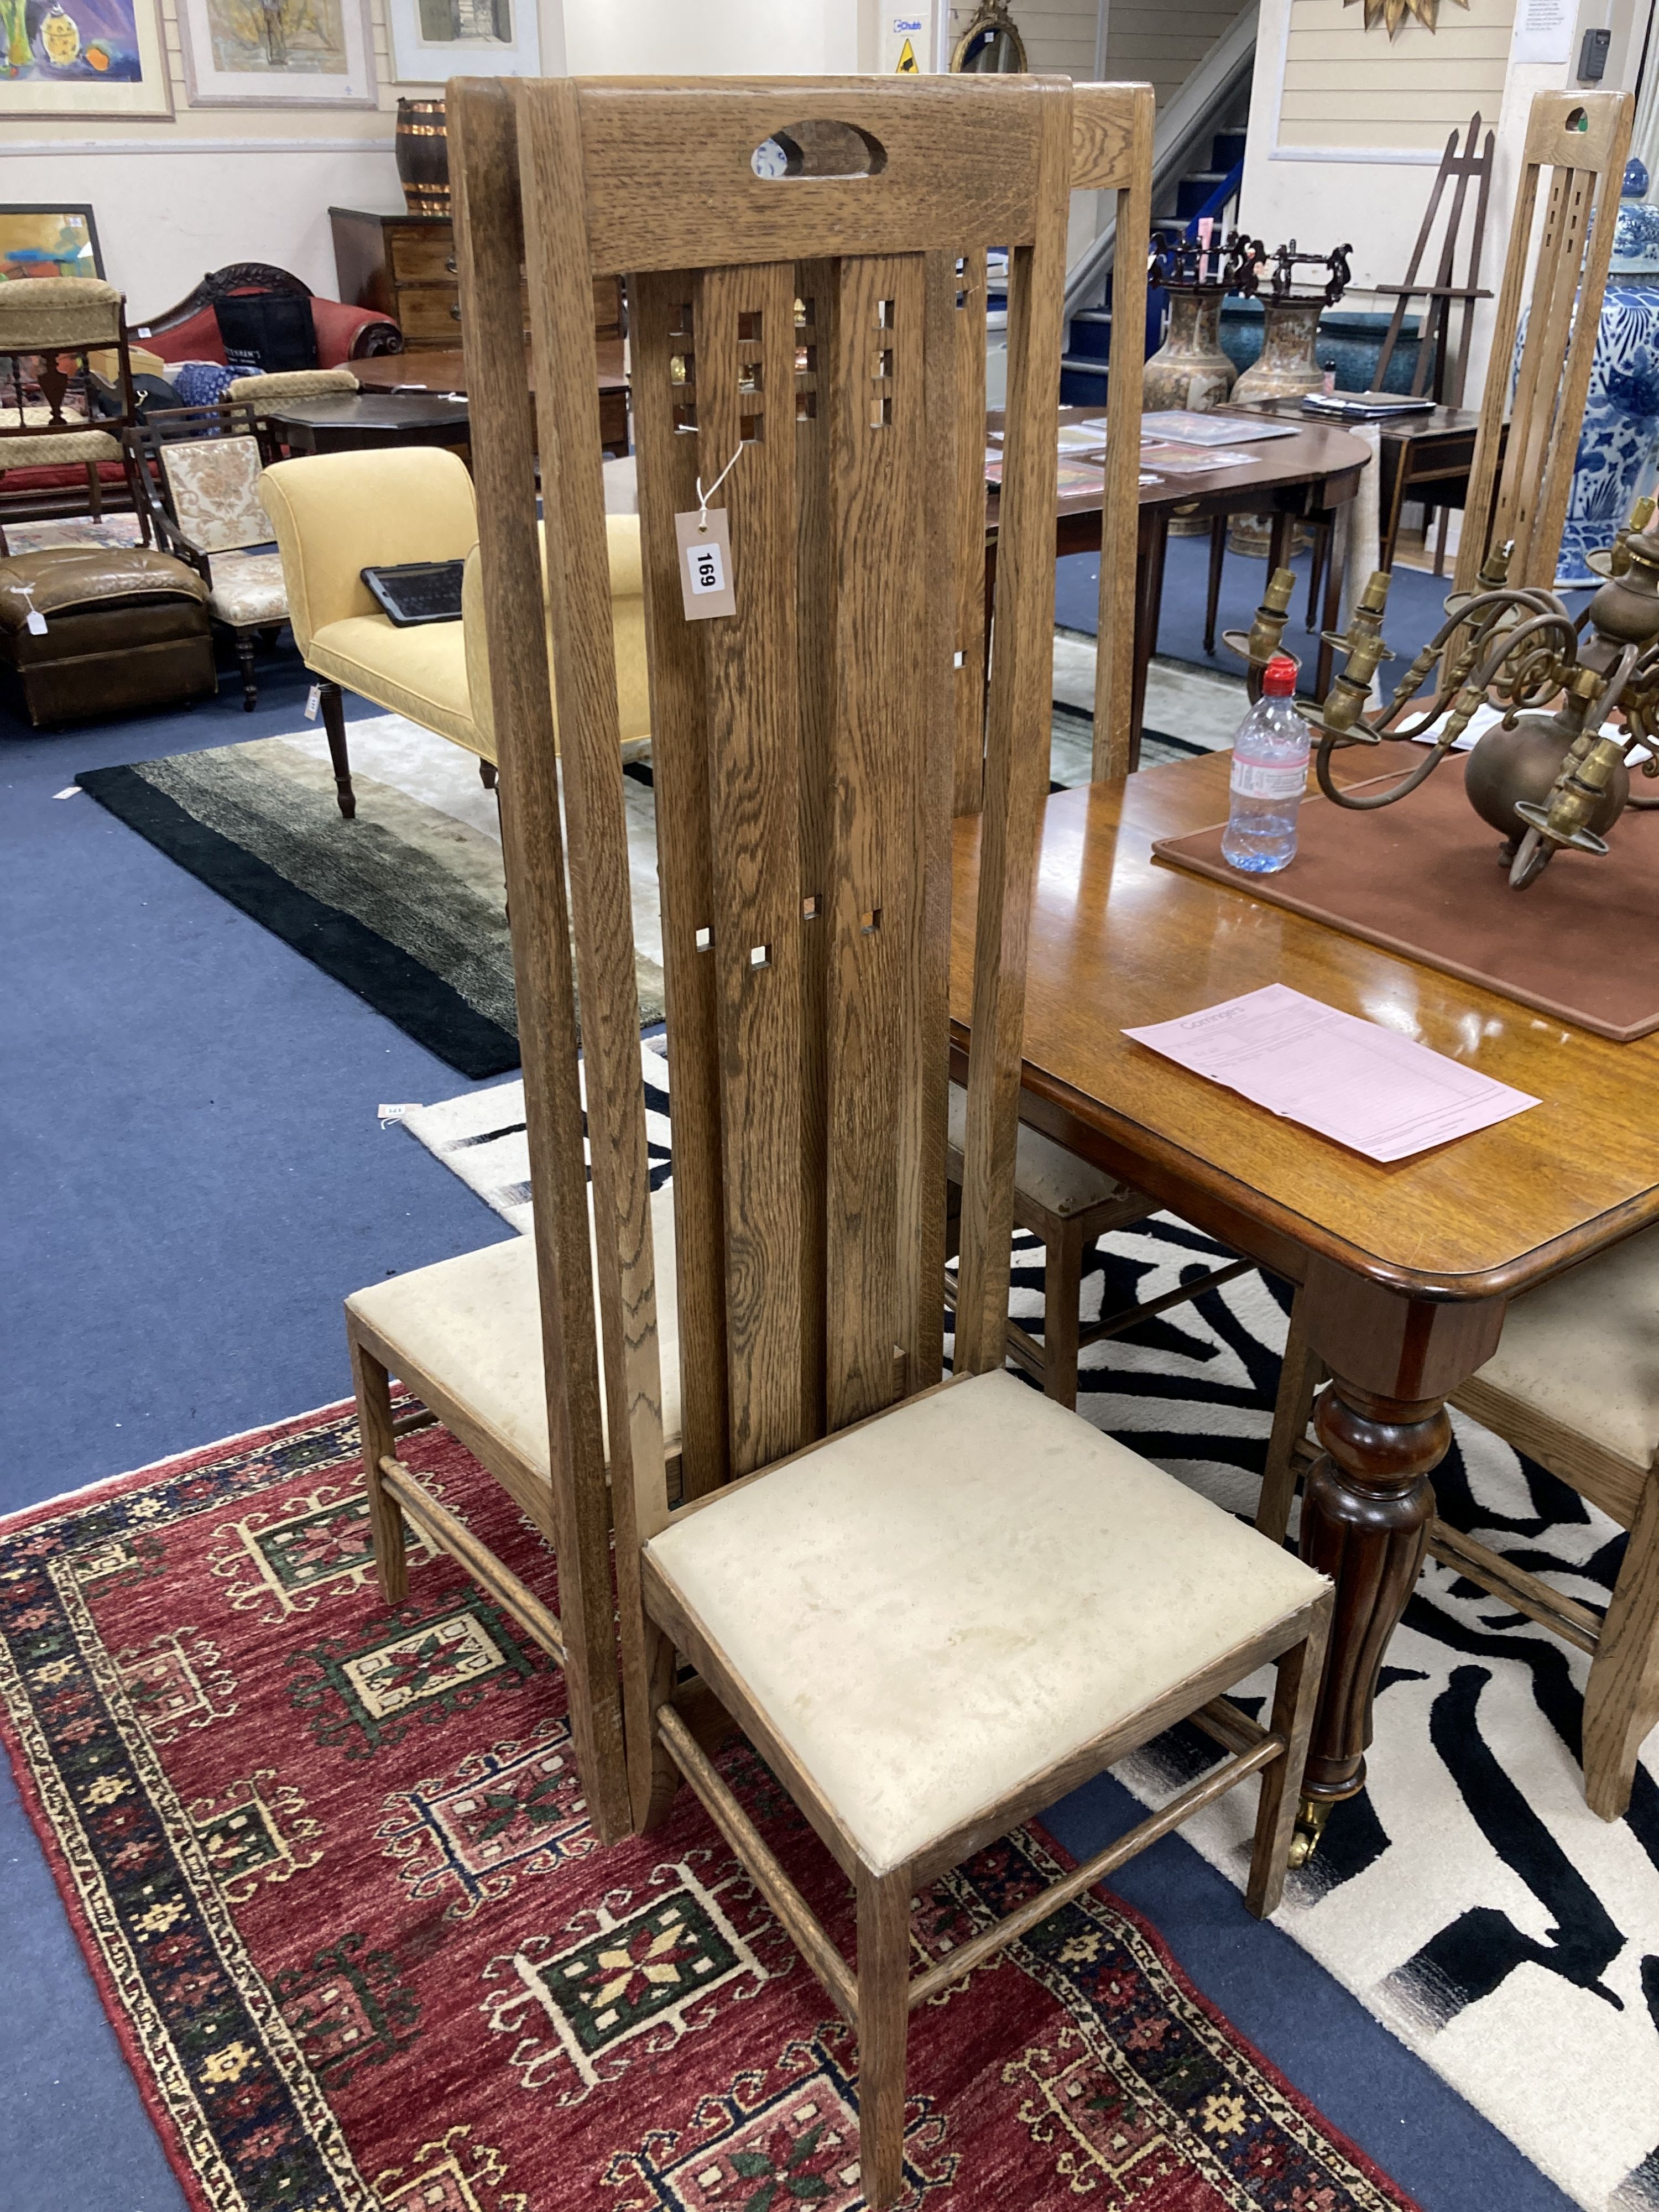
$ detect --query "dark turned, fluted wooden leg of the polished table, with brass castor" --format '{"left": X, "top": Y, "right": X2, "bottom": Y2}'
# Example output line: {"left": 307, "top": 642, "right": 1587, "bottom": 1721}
{"left": 1292, "top": 1259, "right": 1504, "bottom": 1865}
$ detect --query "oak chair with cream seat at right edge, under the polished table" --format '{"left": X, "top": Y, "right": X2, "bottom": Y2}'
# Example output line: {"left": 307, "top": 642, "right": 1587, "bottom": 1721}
{"left": 1256, "top": 1230, "right": 1659, "bottom": 1820}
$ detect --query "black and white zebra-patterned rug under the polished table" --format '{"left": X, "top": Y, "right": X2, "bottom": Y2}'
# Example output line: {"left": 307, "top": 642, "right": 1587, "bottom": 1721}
{"left": 405, "top": 1042, "right": 1659, "bottom": 2212}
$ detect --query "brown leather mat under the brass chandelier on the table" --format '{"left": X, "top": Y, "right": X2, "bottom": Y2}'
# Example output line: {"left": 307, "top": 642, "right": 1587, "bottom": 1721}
{"left": 1152, "top": 743, "right": 1659, "bottom": 1044}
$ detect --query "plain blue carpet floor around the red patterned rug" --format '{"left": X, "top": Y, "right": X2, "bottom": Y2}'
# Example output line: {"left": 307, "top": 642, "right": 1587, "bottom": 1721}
{"left": 0, "top": 641, "right": 1568, "bottom": 2212}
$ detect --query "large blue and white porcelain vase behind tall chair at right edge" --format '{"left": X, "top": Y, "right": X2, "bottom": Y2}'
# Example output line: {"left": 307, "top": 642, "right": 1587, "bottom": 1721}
{"left": 1557, "top": 159, "right": 1659, "bottom": 584}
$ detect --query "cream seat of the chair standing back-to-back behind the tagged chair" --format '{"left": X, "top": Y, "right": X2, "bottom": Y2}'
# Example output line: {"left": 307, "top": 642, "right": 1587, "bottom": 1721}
{"left": 345, "top": 1186, "right": 679, "bottom": 1480}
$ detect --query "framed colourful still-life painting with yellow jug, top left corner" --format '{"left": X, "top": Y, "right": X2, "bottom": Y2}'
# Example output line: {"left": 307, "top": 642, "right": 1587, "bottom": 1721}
{"left": 0, "top": 0, "right": 173, "bottom": 122}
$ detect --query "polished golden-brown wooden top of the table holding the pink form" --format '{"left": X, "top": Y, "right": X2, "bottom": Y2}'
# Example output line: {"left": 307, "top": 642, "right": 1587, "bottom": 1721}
{"left": 951, "top": 748, "right": 1659, "bottom": 1298}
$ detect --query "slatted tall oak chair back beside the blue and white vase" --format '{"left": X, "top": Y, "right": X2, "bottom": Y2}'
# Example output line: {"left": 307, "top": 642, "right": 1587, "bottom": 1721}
{"left": 1453, "top": 93, "right": 1635, "bottom": 591}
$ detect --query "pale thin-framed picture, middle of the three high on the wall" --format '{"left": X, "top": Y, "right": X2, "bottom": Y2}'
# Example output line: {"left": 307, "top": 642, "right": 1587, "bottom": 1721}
{"left": 180, "top": 0, "right": 374, "bottom": 108}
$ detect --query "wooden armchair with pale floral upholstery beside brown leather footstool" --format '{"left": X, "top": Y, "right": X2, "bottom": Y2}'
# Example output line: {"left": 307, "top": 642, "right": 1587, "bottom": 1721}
{"left": 122, "top": 400, "right": 288, "bottom": 714}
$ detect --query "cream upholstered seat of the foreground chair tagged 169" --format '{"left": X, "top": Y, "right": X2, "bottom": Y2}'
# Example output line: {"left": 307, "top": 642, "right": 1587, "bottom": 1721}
{"left": 646, "top": 1371, "right": 1327, "bottom": 1874}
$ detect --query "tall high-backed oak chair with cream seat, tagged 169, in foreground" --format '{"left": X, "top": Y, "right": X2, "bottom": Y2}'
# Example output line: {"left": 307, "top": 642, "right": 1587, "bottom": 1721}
{"left": 449, "top": 77, "right": 1329, "bottom": 2205}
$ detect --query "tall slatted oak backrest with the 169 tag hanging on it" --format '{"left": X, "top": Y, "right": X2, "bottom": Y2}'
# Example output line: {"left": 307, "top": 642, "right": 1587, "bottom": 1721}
{"left": 449, "top": 77, "right": 1150, "bottom": 1809}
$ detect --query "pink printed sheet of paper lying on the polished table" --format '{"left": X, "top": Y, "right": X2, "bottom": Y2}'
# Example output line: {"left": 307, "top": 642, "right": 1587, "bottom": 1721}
{"left": 1124, "top": 982, "right": 1537, "bottom": 1161}
